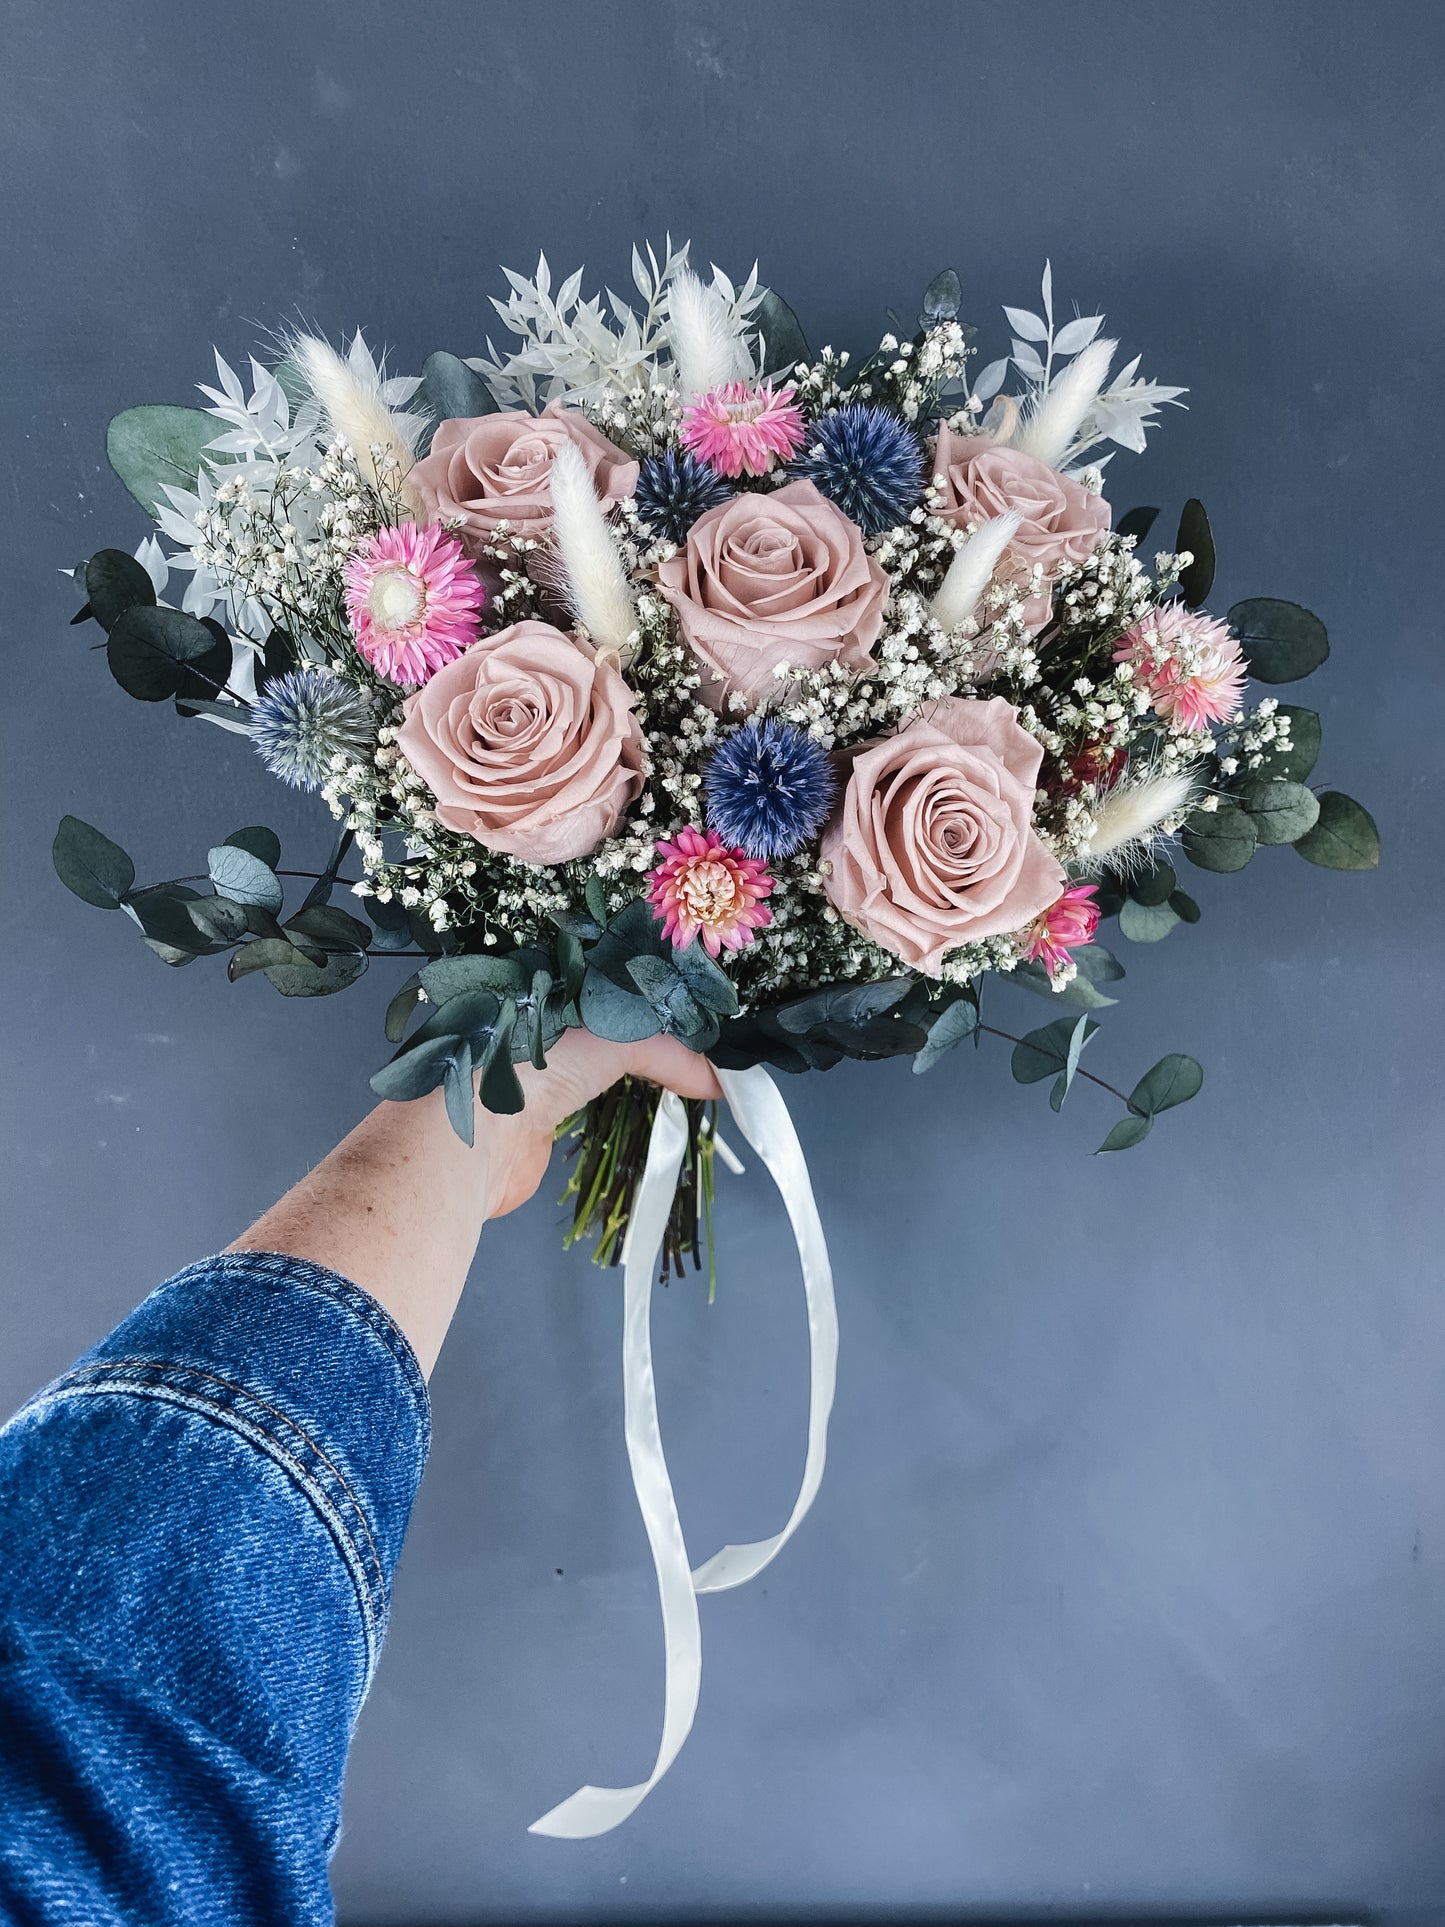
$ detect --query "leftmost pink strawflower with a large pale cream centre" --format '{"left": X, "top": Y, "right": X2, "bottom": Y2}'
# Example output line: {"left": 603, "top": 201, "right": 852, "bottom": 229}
{"left": 343, "top": 522, "right": 487, "bottom": 688}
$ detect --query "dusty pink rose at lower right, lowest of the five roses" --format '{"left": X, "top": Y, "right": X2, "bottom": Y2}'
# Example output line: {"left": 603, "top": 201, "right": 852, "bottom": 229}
{"left": 821, "top": 696, "right": 1065, "bottom": 977}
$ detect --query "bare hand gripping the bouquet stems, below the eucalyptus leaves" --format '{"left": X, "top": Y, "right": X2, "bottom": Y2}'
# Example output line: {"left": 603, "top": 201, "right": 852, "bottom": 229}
{"left": 478, "top": 1031, "right": 723, "bottom": 1218}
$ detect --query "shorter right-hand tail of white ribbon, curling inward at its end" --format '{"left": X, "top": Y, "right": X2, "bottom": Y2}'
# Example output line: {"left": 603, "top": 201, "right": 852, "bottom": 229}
{"left": 692, "top": 1064, "right": 838, "bottom": 1592}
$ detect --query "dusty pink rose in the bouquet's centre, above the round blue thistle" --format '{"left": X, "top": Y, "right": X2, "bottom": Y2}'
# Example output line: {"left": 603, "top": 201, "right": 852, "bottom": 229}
{"left": 657, "top": 482, "right": 888, "bottom": 709}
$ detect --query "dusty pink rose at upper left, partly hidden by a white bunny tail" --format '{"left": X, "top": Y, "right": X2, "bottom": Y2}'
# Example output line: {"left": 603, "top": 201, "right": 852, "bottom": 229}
{"left": 407, "top": 401, "right": 638, "bottom": 553}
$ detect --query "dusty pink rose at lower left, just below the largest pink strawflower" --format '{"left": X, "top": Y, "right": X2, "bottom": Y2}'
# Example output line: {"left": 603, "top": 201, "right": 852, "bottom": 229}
{"left": 397, "top": 620, "right": 642, "bottom": 863}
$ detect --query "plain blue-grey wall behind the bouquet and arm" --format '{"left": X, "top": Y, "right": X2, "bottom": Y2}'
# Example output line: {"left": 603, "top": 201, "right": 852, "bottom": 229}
{"left": 0, "top": 0, "right": 1445, "bottom": 1923}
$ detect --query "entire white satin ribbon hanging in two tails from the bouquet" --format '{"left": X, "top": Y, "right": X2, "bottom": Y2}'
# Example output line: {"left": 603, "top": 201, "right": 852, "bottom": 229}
{"left": 528, "top": 1066, "right": 838, "bottom": 1840}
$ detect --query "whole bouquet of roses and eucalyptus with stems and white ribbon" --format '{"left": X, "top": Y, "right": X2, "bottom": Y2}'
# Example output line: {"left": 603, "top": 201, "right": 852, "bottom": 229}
{"left": 54, "top": 241, "right": 1378, "bottom": 1835}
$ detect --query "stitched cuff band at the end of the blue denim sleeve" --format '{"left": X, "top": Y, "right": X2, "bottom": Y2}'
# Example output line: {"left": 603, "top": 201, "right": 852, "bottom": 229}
{"left": 31, "top": 1251, "right": 432, "bottom": 1676}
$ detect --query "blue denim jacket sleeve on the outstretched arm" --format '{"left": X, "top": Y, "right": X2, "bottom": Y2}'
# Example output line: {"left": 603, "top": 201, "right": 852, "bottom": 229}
{"left": 0, "top": 1253, "right": 430, "bottom": 1927}
